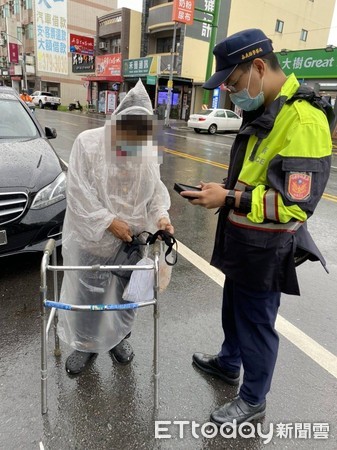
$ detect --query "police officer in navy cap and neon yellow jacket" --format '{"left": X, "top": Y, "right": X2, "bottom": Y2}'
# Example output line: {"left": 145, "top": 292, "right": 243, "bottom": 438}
{"left": 182, "top": 29, "right": 332, "bottom": 425}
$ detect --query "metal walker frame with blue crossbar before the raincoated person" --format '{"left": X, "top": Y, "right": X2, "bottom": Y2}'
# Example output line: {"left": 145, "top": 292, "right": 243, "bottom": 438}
{"left": 40, "top": 239, "right": 160, "bottom": 414}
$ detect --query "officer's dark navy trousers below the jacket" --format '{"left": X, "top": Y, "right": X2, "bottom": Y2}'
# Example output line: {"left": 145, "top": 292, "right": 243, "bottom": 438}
{"left": 218, "top": 278, "right": 281, "bottom": 404}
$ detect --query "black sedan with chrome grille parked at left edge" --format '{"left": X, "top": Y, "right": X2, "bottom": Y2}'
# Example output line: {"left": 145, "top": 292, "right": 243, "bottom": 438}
{"left": 0, "top": 87, "right": 66, "bottom": 257}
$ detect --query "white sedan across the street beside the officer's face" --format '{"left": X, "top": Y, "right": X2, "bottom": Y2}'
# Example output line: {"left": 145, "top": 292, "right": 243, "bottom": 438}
{"left": 187, "top": 109, "right": 242, "bottom": 134}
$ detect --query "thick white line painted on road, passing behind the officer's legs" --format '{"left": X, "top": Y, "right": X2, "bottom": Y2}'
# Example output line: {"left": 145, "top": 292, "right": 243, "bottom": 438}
{"left": 178, "top": 242, "right": 337, "bottom": 378}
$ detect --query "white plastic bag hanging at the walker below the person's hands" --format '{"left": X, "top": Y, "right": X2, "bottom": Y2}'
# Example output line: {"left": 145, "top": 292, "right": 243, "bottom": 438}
{"left": 123, "top": 257, "right": 154, "bottom": 303}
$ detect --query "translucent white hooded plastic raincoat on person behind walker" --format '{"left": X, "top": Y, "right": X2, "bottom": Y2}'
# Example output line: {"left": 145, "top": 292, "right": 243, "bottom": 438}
{"left": 59, "top": 80, "right": 170, "bottom": 353}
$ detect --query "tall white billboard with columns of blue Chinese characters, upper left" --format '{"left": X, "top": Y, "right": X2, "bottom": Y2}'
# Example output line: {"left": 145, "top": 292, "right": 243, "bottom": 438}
{"left": 35, "top": 0, "right": 68, "bottom": 75}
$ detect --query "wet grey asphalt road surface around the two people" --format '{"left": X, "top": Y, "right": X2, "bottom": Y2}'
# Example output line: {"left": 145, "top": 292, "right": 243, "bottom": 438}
{"left": 0, "top": 111, "right": 337, "bottom": 450}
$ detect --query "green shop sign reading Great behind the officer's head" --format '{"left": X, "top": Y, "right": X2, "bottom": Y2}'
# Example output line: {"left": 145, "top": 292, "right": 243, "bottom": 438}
{"left": 276, "top": 49, "right": 337, "bottom": 78}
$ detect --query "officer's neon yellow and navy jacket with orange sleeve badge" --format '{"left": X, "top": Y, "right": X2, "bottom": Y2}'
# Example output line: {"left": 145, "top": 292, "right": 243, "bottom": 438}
{"left": 211, "top": 75, "right": 332, "bottom": 294}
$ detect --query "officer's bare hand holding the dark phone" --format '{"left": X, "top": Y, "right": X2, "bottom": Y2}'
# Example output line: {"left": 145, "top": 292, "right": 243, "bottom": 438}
{"left": 180, "top": 181, "right": 228, "bottom": 209}
